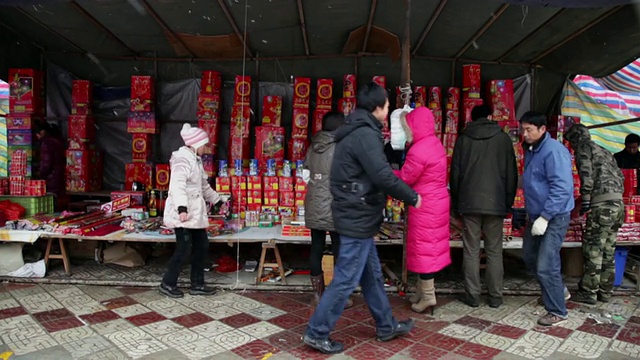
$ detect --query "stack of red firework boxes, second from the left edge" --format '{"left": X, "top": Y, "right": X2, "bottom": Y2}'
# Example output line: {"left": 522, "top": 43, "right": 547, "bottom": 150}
{"left": 66, "top": 80, "right": 102, "bottom": 192}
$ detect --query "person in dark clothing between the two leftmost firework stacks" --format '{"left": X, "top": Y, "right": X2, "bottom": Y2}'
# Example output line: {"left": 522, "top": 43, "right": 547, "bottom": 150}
{"left": 35, "top": 121, "right": 67, "bottom": 198}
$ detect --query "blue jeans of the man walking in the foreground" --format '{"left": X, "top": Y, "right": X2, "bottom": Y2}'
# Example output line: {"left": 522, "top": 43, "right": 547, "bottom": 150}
{"left": 306, "top": 235, "right": 398, "bottom": 340}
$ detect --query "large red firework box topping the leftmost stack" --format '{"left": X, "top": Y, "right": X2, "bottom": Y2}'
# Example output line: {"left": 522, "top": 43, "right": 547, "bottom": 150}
{"left": 8, "top": 69, "right": 45, "bottom": 114}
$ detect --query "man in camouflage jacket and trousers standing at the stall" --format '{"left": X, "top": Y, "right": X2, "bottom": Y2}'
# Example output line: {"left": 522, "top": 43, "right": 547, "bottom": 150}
{"left": 565, "top": 124, "right": 624, "bottom": 304}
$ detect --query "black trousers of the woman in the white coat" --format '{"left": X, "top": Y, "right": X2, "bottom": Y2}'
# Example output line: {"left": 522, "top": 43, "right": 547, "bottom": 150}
{"left": 162, "top": 228, "right": 209, "bottom": 287}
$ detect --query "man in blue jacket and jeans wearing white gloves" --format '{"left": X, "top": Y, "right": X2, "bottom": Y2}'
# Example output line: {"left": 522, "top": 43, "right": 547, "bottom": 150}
{"left": 520, "top": 111, "right": 574, "bottom": 326}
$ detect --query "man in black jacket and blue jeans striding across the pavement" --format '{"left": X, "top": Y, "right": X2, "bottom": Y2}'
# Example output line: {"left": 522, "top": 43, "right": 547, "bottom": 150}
{"left": 304, "top": 83, "right": 421, "bottom": 354}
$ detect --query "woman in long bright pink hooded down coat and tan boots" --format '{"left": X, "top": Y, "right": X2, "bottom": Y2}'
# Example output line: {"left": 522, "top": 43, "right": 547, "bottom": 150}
{"left": 396, "top": 107, "right": 451, "bottom": 313}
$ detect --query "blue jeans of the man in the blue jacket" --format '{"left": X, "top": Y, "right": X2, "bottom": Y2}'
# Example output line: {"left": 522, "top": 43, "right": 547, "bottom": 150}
{"left": 522, "top": 214, "right": 570, "bottom": 318}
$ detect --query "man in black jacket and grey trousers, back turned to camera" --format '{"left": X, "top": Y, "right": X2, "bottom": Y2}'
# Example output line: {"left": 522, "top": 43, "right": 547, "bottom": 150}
{"left": 450, "top": 105, "right": 518, "bottom": 308}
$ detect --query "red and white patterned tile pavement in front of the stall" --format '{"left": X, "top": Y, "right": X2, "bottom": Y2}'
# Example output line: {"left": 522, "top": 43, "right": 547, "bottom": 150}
{"left": 0, "top": 283, "right": 640, "bottom": 360}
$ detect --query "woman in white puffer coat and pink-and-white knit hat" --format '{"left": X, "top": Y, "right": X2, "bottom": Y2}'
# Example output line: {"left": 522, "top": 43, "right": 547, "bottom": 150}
{"left": 160, "top": 124, "right": 220, "bottom": 298}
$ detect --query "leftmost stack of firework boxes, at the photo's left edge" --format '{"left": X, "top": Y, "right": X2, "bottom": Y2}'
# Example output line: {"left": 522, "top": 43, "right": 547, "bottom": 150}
{"left": 2, "top": 68, "right": 45, "bottom": 195}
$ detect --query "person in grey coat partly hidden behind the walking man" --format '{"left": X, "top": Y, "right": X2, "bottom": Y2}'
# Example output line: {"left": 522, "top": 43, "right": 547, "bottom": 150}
{"left": 303, "top": 111, "right": 353, "bottom": 308}
